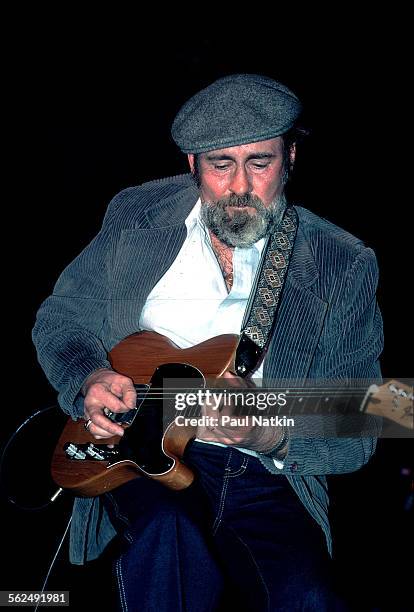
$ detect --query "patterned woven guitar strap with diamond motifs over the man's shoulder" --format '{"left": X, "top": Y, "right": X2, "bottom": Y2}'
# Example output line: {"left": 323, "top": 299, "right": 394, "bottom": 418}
{"left": 235, "top": 206, "right": 298, "bottom": 378}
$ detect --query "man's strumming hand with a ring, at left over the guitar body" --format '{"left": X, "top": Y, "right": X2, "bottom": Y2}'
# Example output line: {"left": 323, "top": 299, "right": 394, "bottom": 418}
{"left": 82, "top": 368, "right": 137, "bottom": 440}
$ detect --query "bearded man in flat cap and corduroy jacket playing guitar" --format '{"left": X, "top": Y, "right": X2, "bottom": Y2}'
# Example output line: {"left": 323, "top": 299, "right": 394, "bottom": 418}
{"left": 34, "top": 75, "right": 382, "bottom": 610}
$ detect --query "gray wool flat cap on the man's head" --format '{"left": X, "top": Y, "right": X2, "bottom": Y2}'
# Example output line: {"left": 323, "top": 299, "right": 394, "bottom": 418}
{"left": 171, "top": 74, "right": 301, "bottom": 153}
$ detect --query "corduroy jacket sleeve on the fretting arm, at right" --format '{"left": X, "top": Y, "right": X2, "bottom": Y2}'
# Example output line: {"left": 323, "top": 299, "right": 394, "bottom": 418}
{"left": 260, "top": 248, "right": 383, "bottom": 475}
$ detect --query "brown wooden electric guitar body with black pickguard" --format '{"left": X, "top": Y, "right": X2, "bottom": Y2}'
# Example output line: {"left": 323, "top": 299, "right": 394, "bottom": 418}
{"left": 51, "top": 331, "right": 239, "bottom": 497}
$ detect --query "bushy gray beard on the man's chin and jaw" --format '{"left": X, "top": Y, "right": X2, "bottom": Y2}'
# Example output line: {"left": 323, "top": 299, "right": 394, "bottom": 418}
{"left": 200, "top": 193, "right": 286, "bottom": 248}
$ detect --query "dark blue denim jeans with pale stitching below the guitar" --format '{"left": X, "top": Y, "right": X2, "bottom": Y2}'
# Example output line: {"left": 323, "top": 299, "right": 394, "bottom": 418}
{"left": 105, "top": 442, "right": 344, "bottom": 612}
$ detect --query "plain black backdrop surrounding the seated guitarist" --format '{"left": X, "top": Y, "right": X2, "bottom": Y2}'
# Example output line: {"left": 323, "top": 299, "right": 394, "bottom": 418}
{"left": 1, "top": 14, "right": 412, "bottom": 610}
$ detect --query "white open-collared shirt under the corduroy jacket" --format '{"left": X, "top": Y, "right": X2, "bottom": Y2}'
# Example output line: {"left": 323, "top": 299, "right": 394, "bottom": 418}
{"left": 139, "top": 199, "right": 283, "bottom": 467}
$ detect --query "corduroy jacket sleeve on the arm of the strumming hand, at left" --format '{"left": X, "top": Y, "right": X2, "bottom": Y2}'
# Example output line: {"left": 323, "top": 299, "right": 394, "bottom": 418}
{"left": 32, "top": 196, "right": 123, "bottom": 419}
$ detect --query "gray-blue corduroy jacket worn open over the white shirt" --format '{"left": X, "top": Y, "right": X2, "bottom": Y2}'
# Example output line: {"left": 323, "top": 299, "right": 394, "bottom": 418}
{"left": 33, "top": 175, "right": 383, "bottom": 564}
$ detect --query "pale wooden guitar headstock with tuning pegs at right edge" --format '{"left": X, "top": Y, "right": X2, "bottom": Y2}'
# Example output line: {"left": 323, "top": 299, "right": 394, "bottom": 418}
{"left": 365, "top": 380, "right": 414, "bottom": 431}
